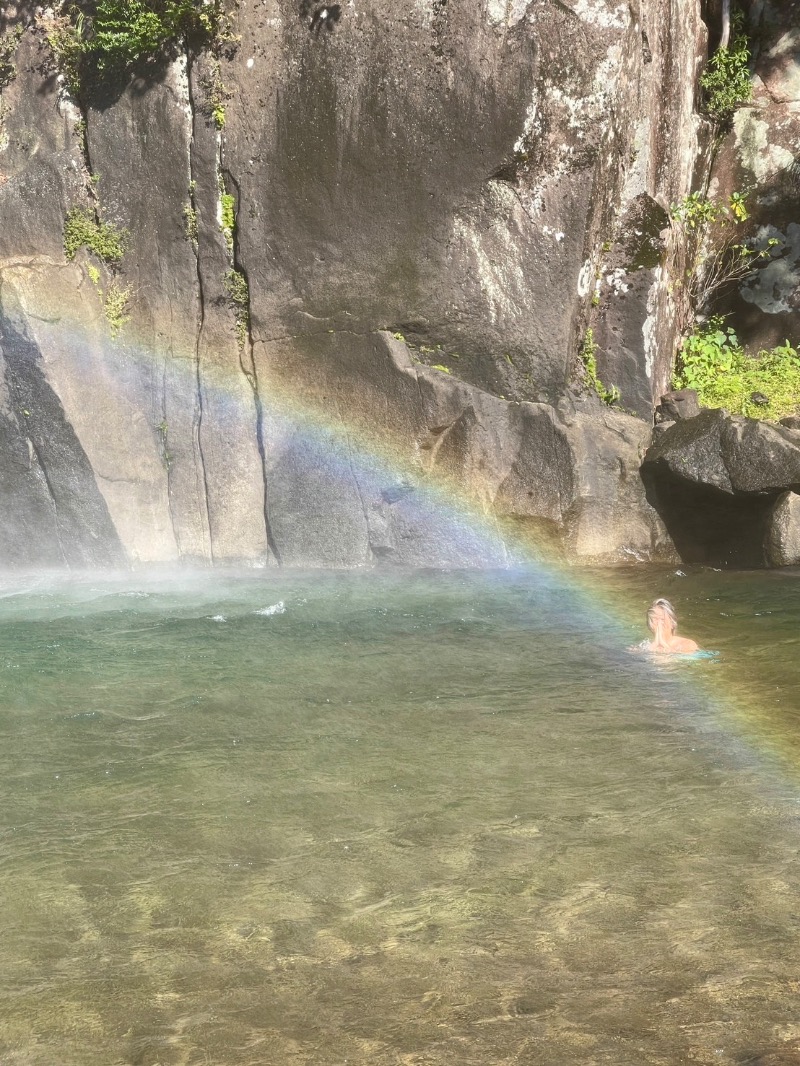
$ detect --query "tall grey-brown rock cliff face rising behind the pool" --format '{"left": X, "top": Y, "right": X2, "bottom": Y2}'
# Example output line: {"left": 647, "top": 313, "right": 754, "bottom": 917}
{"left": 0, "top": 0, "right": 707, "bottom": 566}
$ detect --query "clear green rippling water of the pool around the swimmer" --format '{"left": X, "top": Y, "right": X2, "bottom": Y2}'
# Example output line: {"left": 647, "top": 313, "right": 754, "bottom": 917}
{"left": 0, "top": 571, "right": 800, "bottom": 1066}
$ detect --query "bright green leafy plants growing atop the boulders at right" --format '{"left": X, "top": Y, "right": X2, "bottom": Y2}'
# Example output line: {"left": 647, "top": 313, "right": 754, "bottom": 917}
{"left": 673, "top": 316, "right": 800, "bottom": 419}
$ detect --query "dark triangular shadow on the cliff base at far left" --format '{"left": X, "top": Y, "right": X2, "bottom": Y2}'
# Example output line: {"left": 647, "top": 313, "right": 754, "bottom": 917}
{"left": 0, "top": 313, "right": 126, "bottom": 566}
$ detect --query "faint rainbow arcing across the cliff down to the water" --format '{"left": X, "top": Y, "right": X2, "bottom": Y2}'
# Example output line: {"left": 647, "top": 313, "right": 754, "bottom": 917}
{"left": 3, "top": 287, "right": 800, "bottom": 778}
